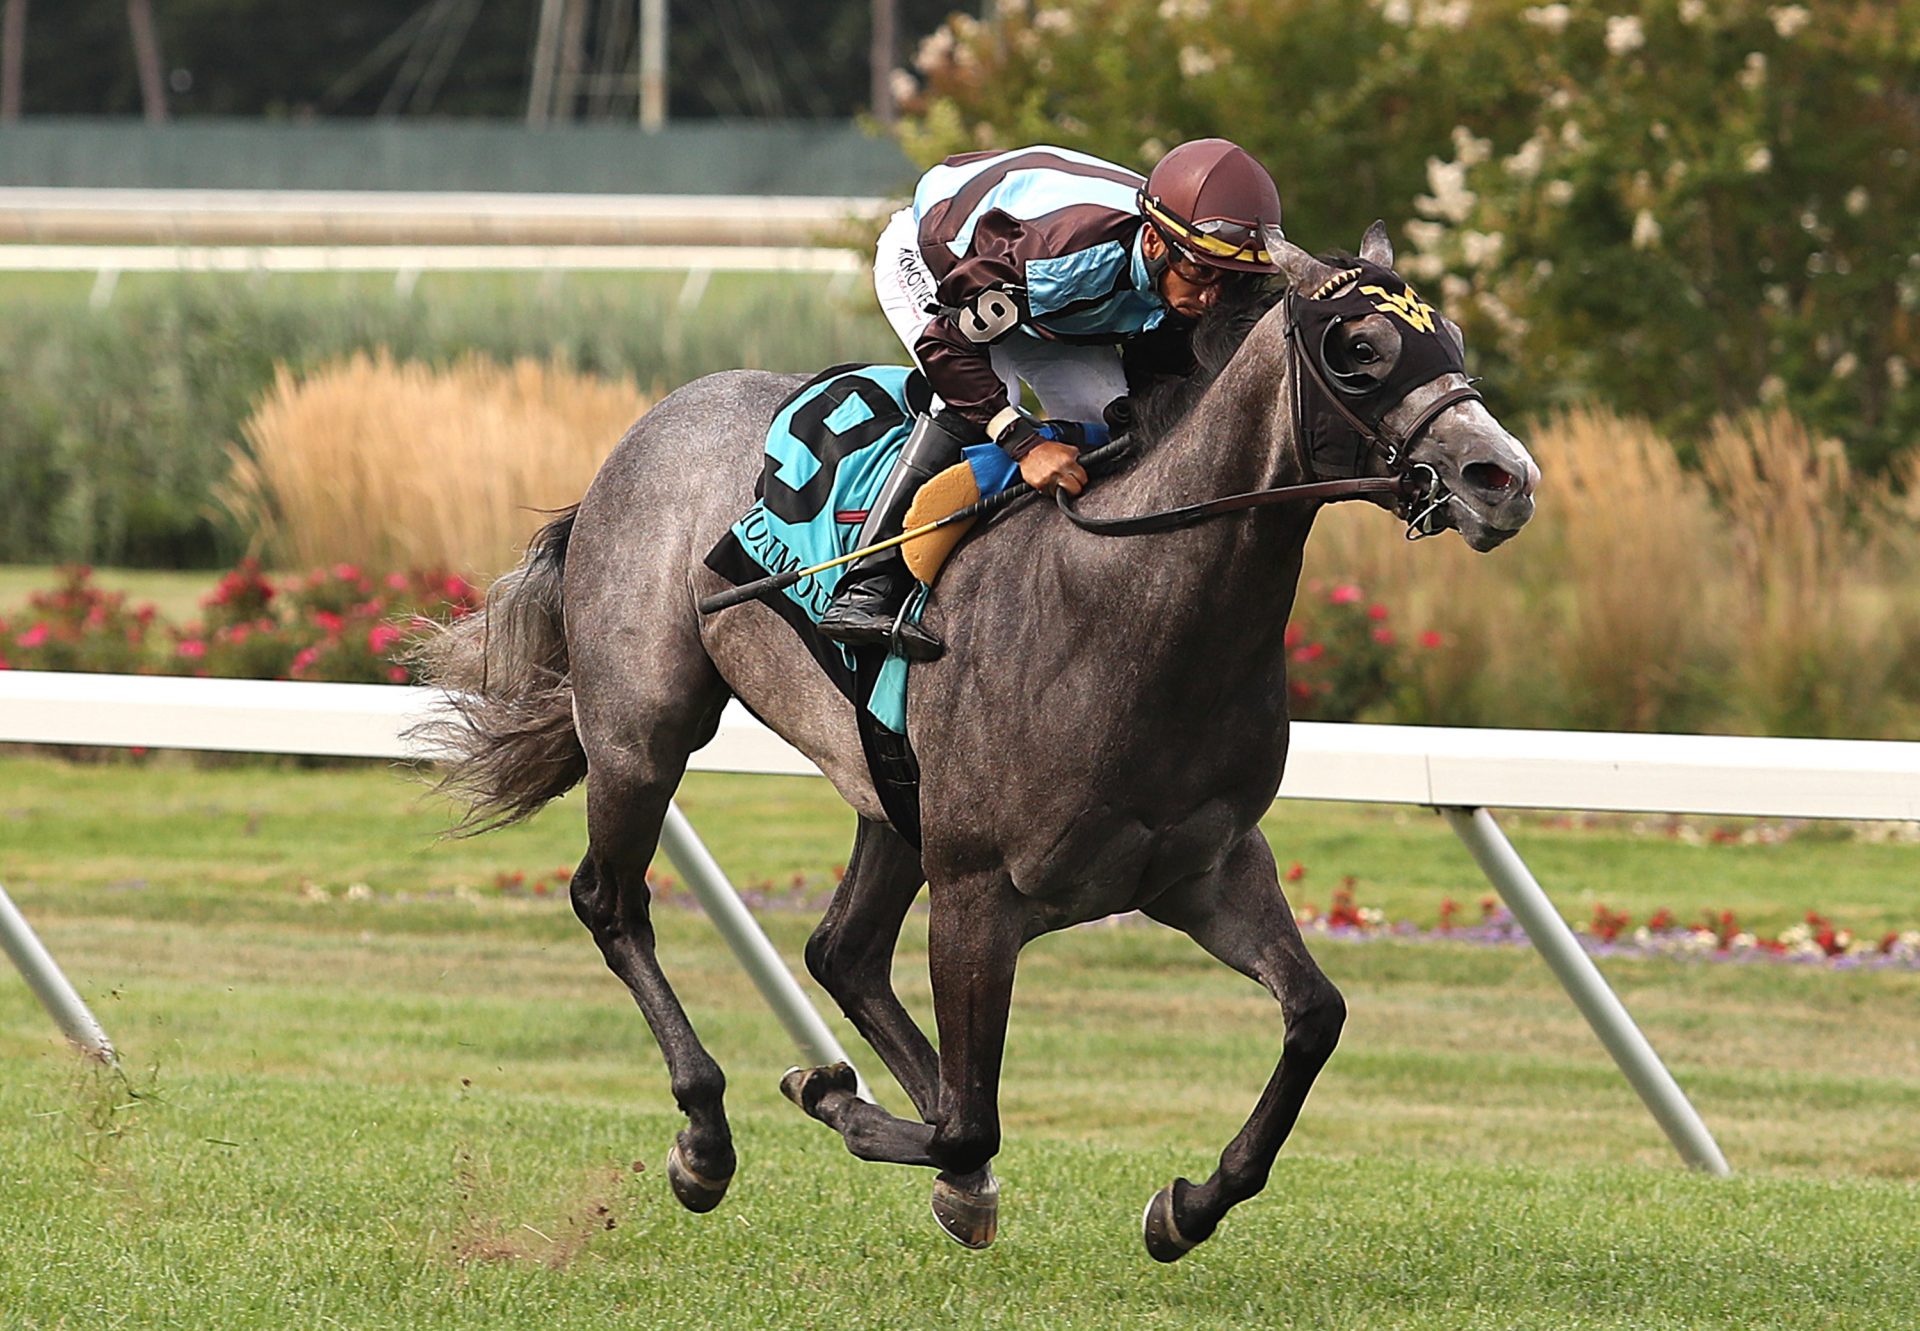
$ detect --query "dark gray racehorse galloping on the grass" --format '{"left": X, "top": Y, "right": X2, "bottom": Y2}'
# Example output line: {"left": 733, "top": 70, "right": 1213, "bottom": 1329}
{"left": 424, "top": 223, "right": 1538, "bottom": 1262}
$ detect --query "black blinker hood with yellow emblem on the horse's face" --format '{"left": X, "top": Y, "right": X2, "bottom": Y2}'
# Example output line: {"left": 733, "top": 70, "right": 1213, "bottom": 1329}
{"left": 1292, "top": 259, "right": 1467, "bottom": 474}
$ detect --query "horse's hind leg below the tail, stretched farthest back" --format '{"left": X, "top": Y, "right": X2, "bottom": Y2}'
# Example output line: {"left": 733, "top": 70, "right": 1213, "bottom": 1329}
{"left": 572, "top": 701, "right": 735, "bottom": 1212}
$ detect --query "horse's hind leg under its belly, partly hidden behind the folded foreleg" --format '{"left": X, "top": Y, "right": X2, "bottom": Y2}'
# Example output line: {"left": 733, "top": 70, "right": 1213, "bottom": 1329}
{"left": 806, "top": 818, "right": 939, "bottom": 1118}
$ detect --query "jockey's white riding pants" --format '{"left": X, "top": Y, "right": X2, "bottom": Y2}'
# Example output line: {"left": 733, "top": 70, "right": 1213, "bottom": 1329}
{"left": 874, "top": 207, "right": 1127, "bottom": 421}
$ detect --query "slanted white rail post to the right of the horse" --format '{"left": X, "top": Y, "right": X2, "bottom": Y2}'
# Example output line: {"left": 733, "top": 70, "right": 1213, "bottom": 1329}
{"left": 1440, "top": 809, "right": 1732, "bottom": 1175}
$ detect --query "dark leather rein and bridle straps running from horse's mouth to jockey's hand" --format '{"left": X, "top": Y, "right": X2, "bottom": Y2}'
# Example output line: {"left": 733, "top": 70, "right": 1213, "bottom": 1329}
{"left": 1054, "top": 294, "right": 1480, "bottom": 540}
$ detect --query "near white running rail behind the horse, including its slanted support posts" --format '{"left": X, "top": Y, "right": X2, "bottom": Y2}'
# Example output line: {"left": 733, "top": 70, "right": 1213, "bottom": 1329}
{"left": 0, "top": 672, "right": 1920, "bottom": 1174}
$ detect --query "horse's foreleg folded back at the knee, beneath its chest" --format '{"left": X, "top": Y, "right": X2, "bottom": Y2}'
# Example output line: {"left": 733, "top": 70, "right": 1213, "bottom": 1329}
{"left": 781, "top": 880, "right": 1025, "bottom": 1248}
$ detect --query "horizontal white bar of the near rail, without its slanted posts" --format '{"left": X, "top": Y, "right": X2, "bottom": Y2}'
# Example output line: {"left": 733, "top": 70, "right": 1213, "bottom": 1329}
{"left": 0, "top": 670, "right": 1920, "bottom": 822}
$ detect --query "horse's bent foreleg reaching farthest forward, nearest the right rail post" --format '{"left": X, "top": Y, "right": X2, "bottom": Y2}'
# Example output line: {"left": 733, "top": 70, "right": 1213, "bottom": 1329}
{"left": 1144, "top": 832, "right": 1346, "bottom": 1262}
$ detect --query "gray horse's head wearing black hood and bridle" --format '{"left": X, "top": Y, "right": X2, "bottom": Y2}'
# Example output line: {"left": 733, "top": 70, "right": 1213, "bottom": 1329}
{"left": 1265, "top": 221, "right": 1540, "bottom": 551}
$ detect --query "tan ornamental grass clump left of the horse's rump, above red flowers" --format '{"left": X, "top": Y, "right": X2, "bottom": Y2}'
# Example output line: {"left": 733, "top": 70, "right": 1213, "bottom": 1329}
{"left": 217, "top": 351, "right": 649, "bottom": 578}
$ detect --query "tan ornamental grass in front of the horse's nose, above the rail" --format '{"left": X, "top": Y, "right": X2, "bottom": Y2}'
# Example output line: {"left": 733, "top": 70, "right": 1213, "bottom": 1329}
{"left": 1308, "top": 409, "right": 1920, "bottom": 738}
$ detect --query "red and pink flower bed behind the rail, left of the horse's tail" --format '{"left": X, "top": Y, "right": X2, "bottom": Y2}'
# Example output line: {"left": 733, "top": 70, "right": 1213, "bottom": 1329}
{"left": 0, "top": 559, "right": 482, "bottom": 684}
